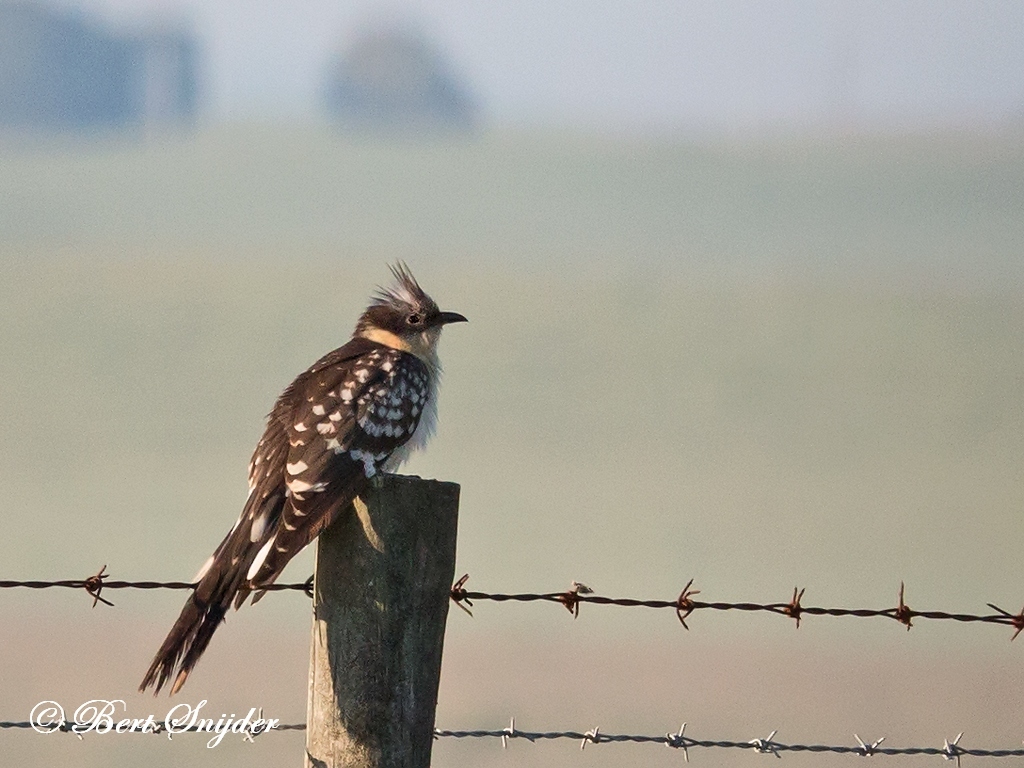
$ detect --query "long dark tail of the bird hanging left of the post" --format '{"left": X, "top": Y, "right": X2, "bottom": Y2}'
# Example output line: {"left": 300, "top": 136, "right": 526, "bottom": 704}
{"left": 138, "top": 557, "right": 248, "bottom": 695}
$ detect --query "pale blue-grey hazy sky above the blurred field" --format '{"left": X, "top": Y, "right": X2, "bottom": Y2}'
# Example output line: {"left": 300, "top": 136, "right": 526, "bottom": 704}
{"left": 52, "top": 0, "right": 1024, "bottom": 131}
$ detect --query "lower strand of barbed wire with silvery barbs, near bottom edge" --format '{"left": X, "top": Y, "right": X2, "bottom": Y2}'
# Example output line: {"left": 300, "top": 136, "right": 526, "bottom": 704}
{"left": 0, "top": 711, "right": 1024, "bottom": 765}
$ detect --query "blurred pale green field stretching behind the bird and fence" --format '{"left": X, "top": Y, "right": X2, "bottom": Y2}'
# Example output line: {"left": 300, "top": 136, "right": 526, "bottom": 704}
{"left": 0, "top": 127, "right": 1024, "bottom": 765}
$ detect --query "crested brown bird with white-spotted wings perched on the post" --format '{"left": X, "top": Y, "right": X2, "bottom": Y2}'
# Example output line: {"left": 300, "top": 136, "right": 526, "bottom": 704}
{"left": 139, "top": 262, "right": 466, "bottom": 695}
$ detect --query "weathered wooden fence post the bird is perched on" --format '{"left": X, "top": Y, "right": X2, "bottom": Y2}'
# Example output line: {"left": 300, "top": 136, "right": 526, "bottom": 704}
{"left": 305, "top": 475, "right": 459, "bottom": 768}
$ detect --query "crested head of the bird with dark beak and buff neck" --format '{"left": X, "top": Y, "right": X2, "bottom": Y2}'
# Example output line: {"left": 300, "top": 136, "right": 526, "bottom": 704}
{"left": 355, "top": 262, "right": 466, "bottom": 365}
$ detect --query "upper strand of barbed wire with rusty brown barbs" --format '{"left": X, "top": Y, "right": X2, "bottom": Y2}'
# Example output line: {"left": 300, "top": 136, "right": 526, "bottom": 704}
{"left": 0, "top": 565, "right": 1024, "bottom": 640}
